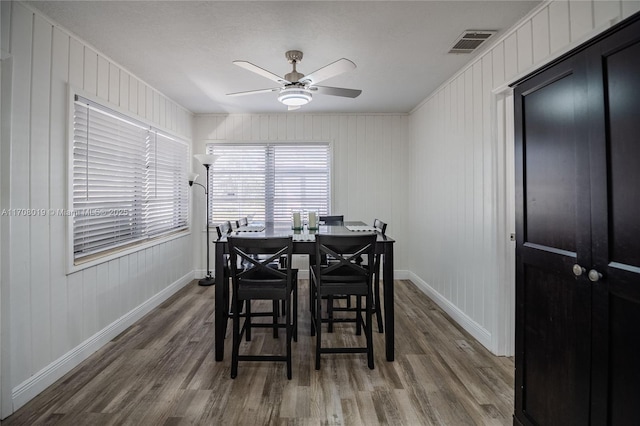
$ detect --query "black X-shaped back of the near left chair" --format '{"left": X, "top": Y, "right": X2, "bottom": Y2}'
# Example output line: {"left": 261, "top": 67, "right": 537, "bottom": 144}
{"left": 228, "top": 236, "right": 293, "bottom": 298}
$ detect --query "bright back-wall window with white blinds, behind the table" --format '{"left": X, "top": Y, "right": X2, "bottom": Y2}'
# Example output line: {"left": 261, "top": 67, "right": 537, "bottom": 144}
{"left": 207, "top": 142, "right": 331, "bottom": 223}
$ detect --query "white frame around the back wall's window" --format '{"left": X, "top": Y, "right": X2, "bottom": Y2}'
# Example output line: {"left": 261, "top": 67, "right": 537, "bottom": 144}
{"left": 205, "top": 140, "right": 335, "bottom": 226}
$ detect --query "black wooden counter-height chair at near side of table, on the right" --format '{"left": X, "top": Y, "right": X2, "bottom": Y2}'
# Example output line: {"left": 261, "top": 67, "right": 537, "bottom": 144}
{"left": 309, "top": 234, "right": 377, "bottom": 370}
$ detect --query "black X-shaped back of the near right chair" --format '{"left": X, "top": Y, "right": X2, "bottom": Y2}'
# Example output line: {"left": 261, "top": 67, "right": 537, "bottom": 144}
{"left": 316, "top": 234, "right": 377, "bottom": 287}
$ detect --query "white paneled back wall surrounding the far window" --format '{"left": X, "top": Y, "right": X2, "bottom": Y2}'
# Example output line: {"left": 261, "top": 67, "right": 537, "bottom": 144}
{"left": 193, "top": 111, "right": 409, "bottom": 278}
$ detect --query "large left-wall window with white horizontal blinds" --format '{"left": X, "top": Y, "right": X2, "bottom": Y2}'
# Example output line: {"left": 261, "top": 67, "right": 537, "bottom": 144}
{"left": 69, "top": 95, "right": 189, "bottom": 262}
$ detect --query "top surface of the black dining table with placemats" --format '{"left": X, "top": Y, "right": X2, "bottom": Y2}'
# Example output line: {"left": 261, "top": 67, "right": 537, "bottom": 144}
{"left": 214, "top": 221, "right": 395, "bottom": 243}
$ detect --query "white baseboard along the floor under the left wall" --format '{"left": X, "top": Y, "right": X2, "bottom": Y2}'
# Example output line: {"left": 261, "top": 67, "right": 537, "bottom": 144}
{"left": 7, "top": 271, "right": 194, "bottom": 415}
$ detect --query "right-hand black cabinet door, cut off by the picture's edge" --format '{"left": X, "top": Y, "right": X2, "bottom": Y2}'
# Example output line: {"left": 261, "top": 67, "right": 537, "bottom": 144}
{"left": 585, "top": 22, "right": 640, "bottom": 425}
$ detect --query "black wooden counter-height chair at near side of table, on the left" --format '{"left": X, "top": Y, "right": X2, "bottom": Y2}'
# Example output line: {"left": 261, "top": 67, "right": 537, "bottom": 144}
{"left": 228, "top": 236, "right": 298, "bottom": 379}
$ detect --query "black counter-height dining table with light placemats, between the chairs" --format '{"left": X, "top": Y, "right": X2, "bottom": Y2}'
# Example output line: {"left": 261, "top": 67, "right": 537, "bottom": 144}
{"left": 214, "top": 222, "right": 395, "bottom": 361}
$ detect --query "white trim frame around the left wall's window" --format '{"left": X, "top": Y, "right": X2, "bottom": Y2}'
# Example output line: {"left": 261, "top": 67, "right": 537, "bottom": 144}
{"left": 69, "top": 86, "right": 192, "bottom": 274}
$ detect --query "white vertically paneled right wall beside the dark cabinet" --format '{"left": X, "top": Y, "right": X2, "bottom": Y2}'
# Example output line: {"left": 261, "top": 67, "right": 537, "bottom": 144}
{"left": 407, "top": 0, "right": 640, "bottom": 354}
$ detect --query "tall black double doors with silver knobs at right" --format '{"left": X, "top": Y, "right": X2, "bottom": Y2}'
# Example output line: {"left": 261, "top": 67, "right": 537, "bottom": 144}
{"left": 514, "top": 14, "right": 640, "bottom": 425}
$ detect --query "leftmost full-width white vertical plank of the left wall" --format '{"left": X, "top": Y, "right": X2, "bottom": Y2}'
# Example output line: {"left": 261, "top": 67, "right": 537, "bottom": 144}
{"left": 10, "top": 3, "right": 33, "bottom": 383}
